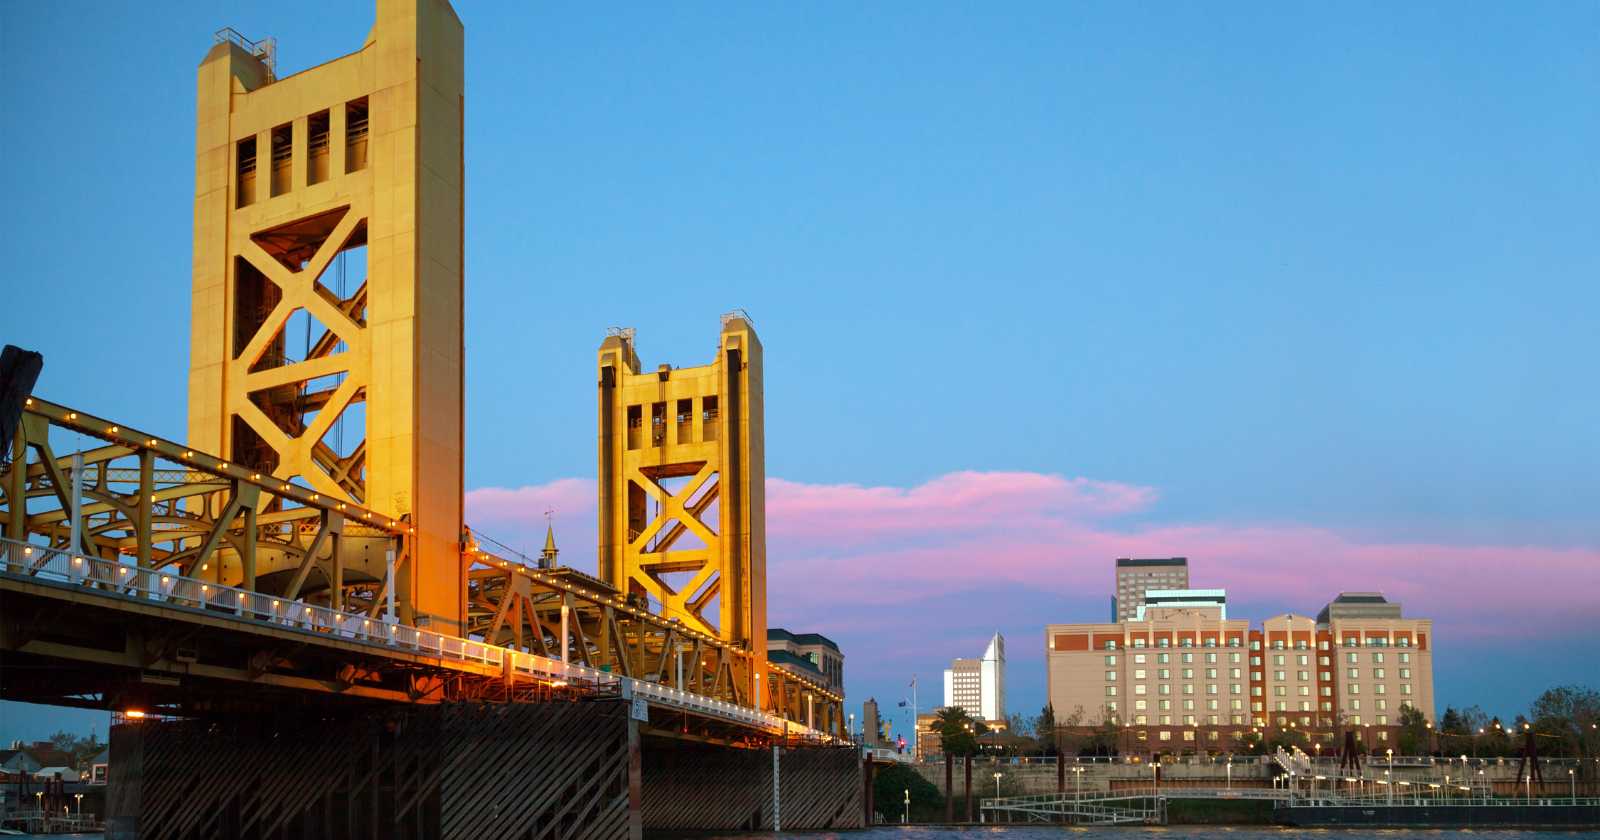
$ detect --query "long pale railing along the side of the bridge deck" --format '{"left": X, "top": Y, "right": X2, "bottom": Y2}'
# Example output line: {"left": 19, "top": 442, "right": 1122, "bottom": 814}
{"left": 0, "top": 538, "right": 824, "bottom": 739}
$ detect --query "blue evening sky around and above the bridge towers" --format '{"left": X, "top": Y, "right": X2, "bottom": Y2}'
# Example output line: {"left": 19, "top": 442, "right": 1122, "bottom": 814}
{"left": 0, "top": 2, "right": 1600, "bottom": 738}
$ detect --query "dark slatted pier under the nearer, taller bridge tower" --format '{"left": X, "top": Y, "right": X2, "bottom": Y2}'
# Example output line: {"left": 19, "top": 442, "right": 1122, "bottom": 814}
{"left": 106, "top": 701, "right": 640, "bottom": 840}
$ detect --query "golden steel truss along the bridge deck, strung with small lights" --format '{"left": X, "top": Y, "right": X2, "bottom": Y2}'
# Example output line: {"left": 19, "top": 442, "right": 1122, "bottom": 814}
{"left": 0, "top": 397, "right": 843, "bottom": 736}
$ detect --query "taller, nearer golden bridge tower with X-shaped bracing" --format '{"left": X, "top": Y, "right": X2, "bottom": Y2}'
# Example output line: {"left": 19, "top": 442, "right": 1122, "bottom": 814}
{"left": 189, "top": 0, "right": 466, "bottom": 634}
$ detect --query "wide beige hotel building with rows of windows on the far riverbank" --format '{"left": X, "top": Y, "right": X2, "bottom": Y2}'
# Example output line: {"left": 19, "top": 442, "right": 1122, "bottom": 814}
{"left": 1045, "top": 589, "right": 1434, "bottom": 754}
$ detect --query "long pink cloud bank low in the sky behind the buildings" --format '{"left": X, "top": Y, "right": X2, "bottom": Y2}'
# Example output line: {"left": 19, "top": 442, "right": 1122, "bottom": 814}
{"left": 467, "top": 472, "right": 1600, "bottom": 638}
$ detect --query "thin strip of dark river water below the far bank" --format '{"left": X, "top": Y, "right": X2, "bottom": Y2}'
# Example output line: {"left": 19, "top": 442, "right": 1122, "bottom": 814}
{"left": 707, "top": 826, "right": 1600, "bottom": 840}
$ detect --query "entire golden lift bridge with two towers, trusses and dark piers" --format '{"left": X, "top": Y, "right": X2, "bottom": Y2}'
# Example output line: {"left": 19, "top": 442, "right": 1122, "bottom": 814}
{"left": 0, "top": 0, "right": 866, "bottom": 837}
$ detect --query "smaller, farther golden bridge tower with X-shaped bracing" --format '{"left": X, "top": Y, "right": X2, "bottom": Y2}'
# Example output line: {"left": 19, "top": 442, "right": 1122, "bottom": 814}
{"left": 598, "top": 314, "right": 766, "bottom": 690}
